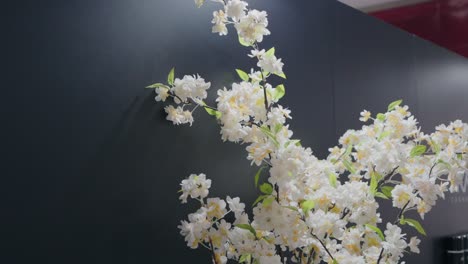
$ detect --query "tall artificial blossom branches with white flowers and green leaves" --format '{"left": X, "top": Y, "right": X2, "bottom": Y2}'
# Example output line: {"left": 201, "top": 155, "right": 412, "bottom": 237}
{"left": 144, "top": 0, "right": 468, "bottom": 264}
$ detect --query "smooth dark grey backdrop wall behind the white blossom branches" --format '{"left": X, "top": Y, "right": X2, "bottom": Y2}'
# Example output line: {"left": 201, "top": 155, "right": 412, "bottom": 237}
{"left": 0, "top": 0, "right": 468, "bottom": 263}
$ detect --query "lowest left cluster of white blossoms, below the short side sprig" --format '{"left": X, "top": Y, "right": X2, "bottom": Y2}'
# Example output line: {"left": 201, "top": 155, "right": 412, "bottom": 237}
{"left": 179, "top": 174, "right": 281, "bottom": 264}
